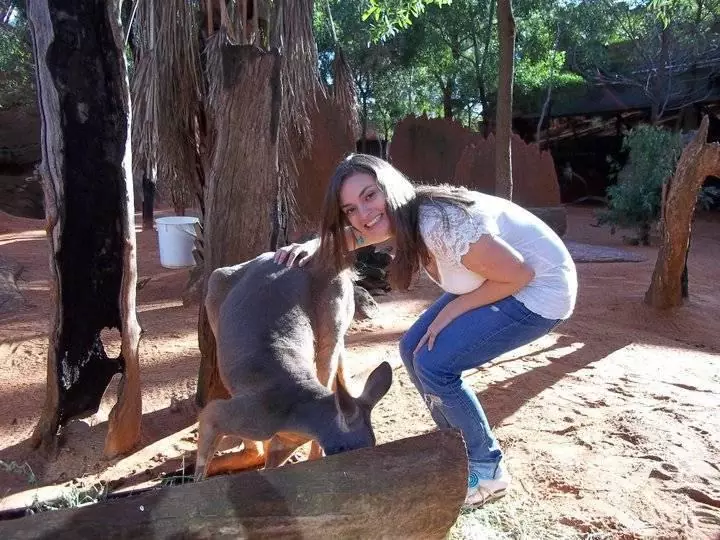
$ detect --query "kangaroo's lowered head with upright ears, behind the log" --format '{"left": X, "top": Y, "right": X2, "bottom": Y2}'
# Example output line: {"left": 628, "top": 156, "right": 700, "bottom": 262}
{"left": 324, "top": 362, "right": 392, "bottom": 456}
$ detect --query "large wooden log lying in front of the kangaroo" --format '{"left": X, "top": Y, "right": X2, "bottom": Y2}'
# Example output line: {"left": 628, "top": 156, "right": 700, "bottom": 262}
{"left": 0, "top": 430, "right": 467, "bottom": 540}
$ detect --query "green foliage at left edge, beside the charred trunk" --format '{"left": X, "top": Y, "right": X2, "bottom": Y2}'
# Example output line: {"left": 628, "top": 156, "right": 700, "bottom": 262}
{"left": 0, "top": 19, "right": 35, "bottom": 109}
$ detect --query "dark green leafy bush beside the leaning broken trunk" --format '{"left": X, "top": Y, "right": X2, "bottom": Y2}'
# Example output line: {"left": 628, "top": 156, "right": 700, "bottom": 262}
{"left": 598, "top": 125, "right": 682, "bottom": 244}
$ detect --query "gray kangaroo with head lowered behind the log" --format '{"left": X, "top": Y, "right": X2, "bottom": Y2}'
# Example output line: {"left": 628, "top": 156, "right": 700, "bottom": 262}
{"left": 195, "top": 253, "right": 392, "bottom": 480}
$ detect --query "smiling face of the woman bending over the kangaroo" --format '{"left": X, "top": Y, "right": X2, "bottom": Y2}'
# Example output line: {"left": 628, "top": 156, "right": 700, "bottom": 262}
{"left": 340, "top": 172, "right": 392, "bottom": 244}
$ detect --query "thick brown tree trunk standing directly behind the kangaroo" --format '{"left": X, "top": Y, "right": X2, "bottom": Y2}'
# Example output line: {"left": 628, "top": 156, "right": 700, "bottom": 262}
{"left": 197, "top": 31, "right": 281, "bottom": 405}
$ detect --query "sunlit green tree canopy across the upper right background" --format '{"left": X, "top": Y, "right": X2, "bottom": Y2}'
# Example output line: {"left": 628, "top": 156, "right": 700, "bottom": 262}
{"left": 315, "top": 0, "right": 720, "bottom": 131}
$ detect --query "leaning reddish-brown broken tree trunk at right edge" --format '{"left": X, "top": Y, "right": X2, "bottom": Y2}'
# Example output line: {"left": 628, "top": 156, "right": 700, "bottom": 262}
{"left": 645, "top": 116, "right": 720, "bottom": 308}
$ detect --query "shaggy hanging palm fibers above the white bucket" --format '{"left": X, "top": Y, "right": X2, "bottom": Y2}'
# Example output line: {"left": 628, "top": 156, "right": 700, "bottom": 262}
{"left": 132, "top": 0, "right": 202, "bottom": 215}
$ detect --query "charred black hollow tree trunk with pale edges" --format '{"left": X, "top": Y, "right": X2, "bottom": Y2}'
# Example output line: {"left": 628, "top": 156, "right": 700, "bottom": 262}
{"left": 28, "top": 0, "right": 141, "bottom": 456}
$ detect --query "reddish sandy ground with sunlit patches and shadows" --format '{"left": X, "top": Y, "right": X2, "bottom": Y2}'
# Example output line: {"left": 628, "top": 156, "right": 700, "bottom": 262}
{"left": 0, "top": 208, "right": 720, "bottom": 538}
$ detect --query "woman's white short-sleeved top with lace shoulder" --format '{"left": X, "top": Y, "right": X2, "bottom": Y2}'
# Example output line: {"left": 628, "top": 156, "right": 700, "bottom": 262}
{"left": 419, "top": 191, "right": 577, "bottom": 319}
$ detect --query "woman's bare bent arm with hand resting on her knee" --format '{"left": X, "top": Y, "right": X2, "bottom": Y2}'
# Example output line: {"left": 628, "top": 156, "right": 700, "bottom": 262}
{"left": 415, "top": 235, "right": 535, "bottom": 354}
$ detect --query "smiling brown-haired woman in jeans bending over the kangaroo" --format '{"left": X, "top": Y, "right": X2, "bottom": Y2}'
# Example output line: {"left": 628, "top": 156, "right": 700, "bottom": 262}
{"left": 275, "top": 154, "right": 577, "bottom": 506}
